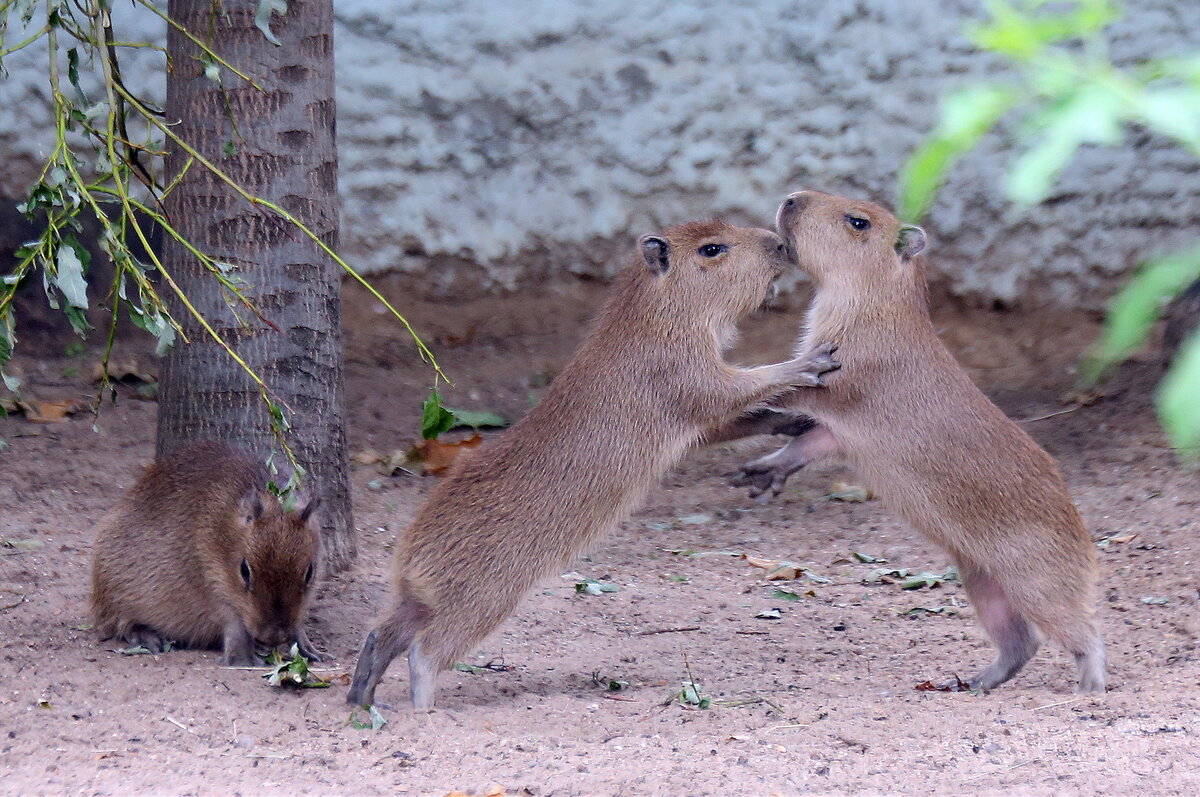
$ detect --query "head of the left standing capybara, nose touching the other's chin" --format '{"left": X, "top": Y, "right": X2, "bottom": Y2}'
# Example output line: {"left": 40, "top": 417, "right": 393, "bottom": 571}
{"left": 638, "top": 221, "right": 790, "bottom": 323}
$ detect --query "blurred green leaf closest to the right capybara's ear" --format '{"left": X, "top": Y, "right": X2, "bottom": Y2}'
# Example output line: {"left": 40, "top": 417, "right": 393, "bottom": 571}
{"left": 896, "top": 85, "right": 1019, "bottom": 223}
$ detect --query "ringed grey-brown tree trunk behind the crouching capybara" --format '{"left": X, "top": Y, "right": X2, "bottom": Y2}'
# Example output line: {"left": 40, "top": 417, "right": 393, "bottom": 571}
{"left": 157, "top": 0, "right": 354, "bottom": 571}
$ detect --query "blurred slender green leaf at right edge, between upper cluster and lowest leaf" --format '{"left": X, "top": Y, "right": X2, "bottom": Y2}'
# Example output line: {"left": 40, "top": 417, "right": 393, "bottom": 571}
{"left": 1080, "top": 246, "right": 1200, "bottom": 388}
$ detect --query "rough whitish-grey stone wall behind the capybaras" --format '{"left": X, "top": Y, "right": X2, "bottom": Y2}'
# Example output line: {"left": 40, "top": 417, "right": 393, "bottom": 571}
{"left": 0, "top": 0, "right": 1200, "bottom": 305}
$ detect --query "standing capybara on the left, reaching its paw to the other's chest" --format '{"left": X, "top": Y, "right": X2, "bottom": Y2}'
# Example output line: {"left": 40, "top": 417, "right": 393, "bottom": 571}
{"left": 348, "top": 222, "right": 835, "bottom": 707}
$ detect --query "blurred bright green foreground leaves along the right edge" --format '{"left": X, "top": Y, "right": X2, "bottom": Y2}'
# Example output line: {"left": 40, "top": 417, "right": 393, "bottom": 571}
{"left": 896, "top": 0, "right": 1200, "bottom": 453}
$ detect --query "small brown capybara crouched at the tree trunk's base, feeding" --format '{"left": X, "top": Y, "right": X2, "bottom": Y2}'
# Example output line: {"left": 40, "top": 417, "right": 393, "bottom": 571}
{"left": 91, "top": 443, "right": 323, "bottom": 665}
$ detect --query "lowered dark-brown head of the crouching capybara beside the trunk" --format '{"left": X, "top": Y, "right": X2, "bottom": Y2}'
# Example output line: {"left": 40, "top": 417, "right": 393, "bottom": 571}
{"left": 230, "top": 490, "right": 322, "bottom": 648}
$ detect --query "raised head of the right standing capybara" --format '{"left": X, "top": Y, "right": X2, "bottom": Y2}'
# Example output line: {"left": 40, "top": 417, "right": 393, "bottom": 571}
{"left": 775, "top": 191, "right": 925, "bottom": 290}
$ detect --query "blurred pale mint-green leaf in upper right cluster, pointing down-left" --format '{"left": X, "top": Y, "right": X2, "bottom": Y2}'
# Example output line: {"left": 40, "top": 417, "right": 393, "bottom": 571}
{"left": 1004, "top": 84, "right": 1126, "bottom": 205}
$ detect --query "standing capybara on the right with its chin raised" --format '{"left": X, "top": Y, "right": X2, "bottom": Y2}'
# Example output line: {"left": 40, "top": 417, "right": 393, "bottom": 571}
{"left": 763, "top": 191, "right": 1104, "bottom": 691}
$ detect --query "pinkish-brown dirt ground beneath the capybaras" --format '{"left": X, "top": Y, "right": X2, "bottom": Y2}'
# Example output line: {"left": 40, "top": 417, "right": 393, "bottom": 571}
{"left": 0, "top": 284, "right": 1200, "bottom": 795}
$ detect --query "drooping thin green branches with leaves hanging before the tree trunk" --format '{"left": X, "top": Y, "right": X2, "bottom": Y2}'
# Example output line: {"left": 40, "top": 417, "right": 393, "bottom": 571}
{"left": 0, "top": 0, "right": 445, "bottom": 470}
